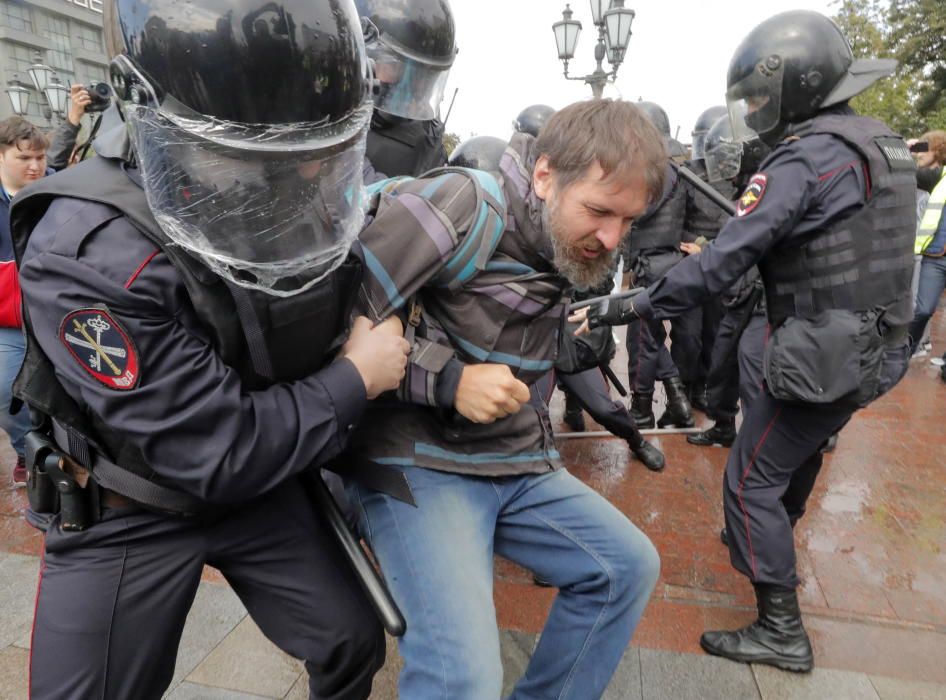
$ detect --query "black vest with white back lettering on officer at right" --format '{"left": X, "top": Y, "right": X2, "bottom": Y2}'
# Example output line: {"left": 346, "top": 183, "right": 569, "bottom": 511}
{"left": 759, "top": 115, "right": 916, "bottom": 327}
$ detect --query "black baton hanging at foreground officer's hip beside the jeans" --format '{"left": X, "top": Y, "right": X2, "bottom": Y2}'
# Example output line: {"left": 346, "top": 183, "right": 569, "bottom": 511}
{"left": 302, "top": 470, "right": 407, "bottom": 637}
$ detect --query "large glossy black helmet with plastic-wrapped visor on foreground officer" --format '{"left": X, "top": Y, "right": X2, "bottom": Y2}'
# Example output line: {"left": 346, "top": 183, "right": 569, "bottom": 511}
{"left": 105, "top": 0, "right": 372, "bottom": 296}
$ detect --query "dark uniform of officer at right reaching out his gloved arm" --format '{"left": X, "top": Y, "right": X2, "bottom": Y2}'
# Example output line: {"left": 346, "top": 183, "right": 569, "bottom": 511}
{"left": 633, "top": 108, "right": 915, "bottom": 589}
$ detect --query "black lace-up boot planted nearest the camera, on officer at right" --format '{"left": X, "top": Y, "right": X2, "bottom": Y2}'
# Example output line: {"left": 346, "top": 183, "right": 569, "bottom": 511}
{"left": 700, "top": 584, "right": 814, "bottom": 673}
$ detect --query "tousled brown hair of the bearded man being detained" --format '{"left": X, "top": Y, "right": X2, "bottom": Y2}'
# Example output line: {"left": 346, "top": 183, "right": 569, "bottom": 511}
{"left": 535, "top": 99, "right": 668, "bottom": 203}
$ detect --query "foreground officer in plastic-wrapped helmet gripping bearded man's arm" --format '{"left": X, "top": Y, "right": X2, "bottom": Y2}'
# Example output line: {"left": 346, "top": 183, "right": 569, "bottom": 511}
{"left": 13, "top": 0, "right": 408, "bottom": 700}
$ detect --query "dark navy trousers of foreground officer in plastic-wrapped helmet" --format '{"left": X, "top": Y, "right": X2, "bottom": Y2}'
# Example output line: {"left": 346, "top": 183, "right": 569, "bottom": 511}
{"left": 30, "top": 480, "right": 384, "bottom": 700}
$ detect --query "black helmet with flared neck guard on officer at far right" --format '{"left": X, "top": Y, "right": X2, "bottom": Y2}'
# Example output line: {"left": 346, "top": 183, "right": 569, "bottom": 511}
{"left": 726, "top": 10, "right": 897, "bottom": 145}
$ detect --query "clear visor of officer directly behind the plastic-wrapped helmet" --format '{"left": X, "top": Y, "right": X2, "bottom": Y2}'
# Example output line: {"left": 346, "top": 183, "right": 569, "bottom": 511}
{"left": 365, "top": 38, "right": 450, "bottom": 121}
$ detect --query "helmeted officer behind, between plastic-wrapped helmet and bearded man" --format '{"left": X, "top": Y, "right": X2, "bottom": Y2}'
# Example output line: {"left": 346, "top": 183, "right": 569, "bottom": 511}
{"left": 355, "top": 0, "right": 457, "bottom": 177}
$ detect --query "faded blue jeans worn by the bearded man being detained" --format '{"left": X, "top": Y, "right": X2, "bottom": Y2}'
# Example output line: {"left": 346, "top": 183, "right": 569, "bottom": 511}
{"left": 349, "top": 467, "right": 660, "bottom": 700}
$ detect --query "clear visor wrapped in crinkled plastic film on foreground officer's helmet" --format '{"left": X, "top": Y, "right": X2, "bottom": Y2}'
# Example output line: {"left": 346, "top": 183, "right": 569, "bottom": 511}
{"left": 127, "top": 103, "right": 371, "bottom": 296}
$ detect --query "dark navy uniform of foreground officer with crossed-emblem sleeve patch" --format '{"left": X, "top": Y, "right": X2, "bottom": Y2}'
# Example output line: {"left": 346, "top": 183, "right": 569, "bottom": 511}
{"left": 13, "top": 152, "right": 384, "bottom": 700}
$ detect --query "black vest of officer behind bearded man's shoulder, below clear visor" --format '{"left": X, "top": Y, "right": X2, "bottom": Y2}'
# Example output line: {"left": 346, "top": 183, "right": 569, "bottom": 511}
{"left": 365, "top": 114, "right": 447, "bottom": 177}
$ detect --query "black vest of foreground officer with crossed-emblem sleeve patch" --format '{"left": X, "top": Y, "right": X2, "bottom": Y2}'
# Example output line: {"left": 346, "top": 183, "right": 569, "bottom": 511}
{"left": 12, "top": 157, "right": 362, "bottom": 513}
